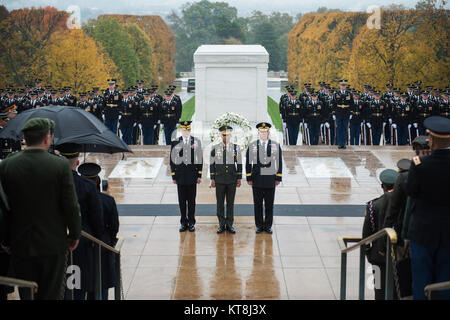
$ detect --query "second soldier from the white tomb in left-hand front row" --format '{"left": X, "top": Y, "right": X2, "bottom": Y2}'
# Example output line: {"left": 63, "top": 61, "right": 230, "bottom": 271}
{"left": 138, "top": 89, "right": 159, "bottom": 145}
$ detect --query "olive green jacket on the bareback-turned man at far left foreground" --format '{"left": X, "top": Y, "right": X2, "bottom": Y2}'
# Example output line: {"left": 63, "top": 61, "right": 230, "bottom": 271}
{"left": 0, "top": 149, "right": 81, "bottom": 257}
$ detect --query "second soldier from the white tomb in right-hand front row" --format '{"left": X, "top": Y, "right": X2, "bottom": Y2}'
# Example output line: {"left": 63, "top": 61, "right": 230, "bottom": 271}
{"left": 305, "top": 92, "right": 326, "bottom": 146}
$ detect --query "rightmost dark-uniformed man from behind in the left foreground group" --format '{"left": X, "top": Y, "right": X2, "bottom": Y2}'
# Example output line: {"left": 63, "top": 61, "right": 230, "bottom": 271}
{"left": 78, "top": 162, "right": 119, "bottom": 300}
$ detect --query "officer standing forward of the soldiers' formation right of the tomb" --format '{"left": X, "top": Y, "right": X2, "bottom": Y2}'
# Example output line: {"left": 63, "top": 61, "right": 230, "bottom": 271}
{"left": 333, "top": 80, "right": 353, "bottom": 149}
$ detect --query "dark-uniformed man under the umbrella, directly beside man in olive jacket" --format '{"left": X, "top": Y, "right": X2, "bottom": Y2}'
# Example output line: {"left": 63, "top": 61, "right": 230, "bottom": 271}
{"left": 56, "top": 143, "right": 104, "bottom": 300}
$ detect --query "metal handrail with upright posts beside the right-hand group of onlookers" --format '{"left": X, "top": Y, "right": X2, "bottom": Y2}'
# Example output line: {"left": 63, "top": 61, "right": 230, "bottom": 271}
{"left": 337, "top": 228, "right": 397, "bottom": 300}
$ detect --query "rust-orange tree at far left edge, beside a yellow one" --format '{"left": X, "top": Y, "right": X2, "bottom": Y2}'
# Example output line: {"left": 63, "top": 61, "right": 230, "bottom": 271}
{"left": 0, "top": 7, "right": 69, "bottom": 86}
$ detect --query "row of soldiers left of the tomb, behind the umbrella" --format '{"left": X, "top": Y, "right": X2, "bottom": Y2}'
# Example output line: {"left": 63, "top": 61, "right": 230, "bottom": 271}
{"left": 0, "top": 79, "right": 182, "bottom": 145}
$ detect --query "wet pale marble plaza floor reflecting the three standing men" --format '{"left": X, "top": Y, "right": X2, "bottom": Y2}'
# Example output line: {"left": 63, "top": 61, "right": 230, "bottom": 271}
{"left": 86, "top": 146, "right": 413, "bottom": 299}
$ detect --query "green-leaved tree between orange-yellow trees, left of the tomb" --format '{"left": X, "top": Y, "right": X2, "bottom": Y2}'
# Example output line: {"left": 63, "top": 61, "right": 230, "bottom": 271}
{"left": 83, "top": 17, "right": 141, "bottom": 87}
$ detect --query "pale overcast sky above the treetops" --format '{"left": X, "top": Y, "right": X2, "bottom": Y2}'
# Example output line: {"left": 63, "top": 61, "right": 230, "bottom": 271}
{"left": 0, "top": 0, "right": 448, "bottom": 21}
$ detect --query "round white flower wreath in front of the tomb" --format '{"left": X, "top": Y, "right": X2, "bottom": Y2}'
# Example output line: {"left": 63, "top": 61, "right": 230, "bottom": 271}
{"left": 209, "top": 112, "right": 253, "bottom": 150}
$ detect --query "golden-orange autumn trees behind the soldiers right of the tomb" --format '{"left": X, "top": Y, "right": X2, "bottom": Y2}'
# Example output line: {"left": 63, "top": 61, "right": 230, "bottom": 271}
{"left": 288, "top": 8, "right": 450, "bottom": 90}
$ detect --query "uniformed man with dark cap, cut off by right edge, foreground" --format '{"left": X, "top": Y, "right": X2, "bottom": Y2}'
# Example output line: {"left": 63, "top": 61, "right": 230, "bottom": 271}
{"left": 406, "top": 116, "right": 450, "bottom": 300}
